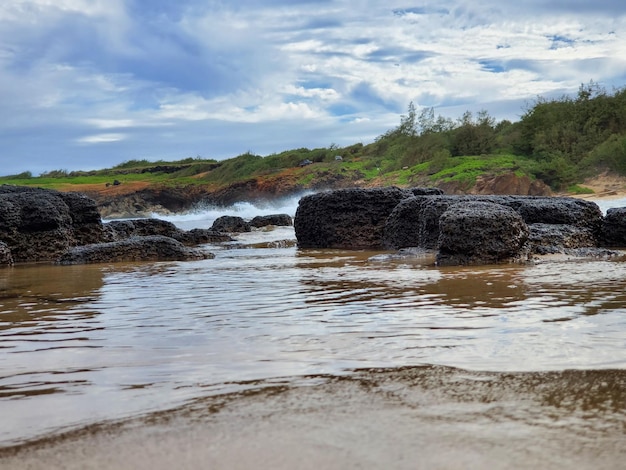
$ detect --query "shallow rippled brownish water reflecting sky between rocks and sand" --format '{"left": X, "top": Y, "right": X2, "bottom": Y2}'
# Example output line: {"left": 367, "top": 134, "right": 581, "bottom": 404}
{"left": 0, "top": 229, "right": 626, "bottom": 445}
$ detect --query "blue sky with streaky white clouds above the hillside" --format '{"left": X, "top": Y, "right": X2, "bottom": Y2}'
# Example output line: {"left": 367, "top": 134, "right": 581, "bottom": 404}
{"left": 0, "top": 0, "right": 626, "bottom": 175}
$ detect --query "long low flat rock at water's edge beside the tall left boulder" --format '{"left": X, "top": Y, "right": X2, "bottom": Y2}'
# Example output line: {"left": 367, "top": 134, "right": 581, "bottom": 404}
{"left": 57, "top": 235, "right": 214, "bottom": 265}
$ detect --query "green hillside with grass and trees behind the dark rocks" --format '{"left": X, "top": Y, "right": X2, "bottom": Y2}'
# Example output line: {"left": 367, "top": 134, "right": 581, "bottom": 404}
{"left": 0, "top": 82, "right": 626, "bottom": 193}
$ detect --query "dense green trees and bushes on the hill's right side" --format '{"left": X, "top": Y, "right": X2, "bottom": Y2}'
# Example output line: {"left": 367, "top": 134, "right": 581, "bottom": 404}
{"left": 375, "top": 81, "right": 626, "bottom": 189}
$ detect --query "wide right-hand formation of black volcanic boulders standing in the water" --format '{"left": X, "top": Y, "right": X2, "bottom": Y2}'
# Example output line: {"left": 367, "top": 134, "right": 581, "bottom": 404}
{"left": 294, "top": 188, "right": 626, "bottom": 265}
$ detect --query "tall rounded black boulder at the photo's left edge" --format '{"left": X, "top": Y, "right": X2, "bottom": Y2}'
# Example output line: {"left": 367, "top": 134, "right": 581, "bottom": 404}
{"left": 0, "top": 185, "right": 104, "bottom": 262}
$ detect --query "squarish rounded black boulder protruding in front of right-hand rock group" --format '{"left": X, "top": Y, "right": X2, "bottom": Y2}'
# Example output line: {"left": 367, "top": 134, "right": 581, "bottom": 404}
{"left": 437, "top": 202, "right": 529, "bottom": 266}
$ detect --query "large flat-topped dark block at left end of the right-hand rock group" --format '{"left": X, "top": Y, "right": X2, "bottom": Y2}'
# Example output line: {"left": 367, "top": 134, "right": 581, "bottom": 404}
{"left": 294, "top": 187, "right": 412, "bottom": 248}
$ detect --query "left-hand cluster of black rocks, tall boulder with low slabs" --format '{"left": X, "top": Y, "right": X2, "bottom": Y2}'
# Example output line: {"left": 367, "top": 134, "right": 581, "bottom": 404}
{"left": 0, "top": 185, "right": 224, "bottom": 266}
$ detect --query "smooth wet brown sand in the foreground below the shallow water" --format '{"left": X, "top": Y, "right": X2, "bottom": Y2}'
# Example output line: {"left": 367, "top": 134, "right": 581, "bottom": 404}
{"left": 0, "top": 366, "right": 626, "bottom": 470}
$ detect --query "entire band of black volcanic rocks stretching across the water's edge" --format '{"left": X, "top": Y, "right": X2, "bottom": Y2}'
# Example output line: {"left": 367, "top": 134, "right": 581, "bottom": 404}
{"left": 0, "top": 185, "right": 626, "bottom": 266}
